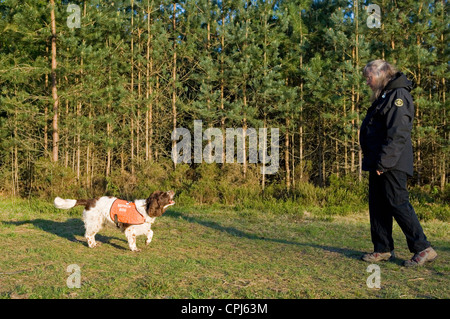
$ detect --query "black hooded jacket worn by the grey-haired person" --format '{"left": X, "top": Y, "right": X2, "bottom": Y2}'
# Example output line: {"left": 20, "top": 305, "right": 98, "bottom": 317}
{"left": 359, "top": 72, "right": 414, "bottom": 176}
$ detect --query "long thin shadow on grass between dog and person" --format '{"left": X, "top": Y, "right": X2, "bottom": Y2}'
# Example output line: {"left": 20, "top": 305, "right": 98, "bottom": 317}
{"left": 164, "top": 210, "right": 362, "bottom": 260}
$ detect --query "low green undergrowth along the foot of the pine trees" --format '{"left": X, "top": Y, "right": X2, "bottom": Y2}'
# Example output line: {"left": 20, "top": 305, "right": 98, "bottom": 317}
{"left": 0, "top": 159, "right": 450, "bottom": 221}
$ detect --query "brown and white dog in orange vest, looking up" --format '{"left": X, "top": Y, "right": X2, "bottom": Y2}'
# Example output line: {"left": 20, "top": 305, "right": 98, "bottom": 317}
{"left": 54, "top": 191, "right": 175, "bottom": 251}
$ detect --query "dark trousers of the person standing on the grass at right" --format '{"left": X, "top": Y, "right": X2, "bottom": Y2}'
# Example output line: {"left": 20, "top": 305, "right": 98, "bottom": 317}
{"left": 369, "top": 170, "right": 431, "bottom": 253}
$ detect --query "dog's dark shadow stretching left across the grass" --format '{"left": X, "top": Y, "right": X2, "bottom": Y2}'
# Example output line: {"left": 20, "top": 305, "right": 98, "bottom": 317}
{"left": 2, "top": 218, "right": 127, "bottom": 250}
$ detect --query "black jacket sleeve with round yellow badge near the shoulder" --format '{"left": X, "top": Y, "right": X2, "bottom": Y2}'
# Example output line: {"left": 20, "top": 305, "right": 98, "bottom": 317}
{"left": 377, "top": 90, "right": 414, "bottom": 172}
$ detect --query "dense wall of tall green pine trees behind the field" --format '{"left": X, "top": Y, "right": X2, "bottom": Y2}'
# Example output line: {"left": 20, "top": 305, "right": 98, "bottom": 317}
{"left": 0, "top": 0, "right": 450, "bottom": 203}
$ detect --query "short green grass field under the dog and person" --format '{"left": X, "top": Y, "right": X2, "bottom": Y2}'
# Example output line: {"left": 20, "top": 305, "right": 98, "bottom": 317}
{"left": 0, "top": 199, "right": 450, "bottom": 299}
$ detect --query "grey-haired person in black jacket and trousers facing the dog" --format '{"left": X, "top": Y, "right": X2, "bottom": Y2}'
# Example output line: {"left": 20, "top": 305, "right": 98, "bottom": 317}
{"left": 360, "top": 60, "right": 437, "bottom": 267}
